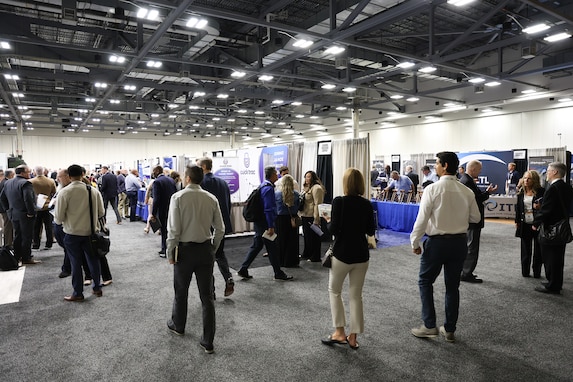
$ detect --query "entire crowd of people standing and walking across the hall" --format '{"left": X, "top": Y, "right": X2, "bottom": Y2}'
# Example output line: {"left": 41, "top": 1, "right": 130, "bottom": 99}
{"left": 0, "top": 157, "right": 573, "bottom": 353}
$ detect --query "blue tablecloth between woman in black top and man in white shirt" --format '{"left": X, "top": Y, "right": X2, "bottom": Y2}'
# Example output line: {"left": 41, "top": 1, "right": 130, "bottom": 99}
{"left": 372, "top": 200, "right": 420, "bottom": 232}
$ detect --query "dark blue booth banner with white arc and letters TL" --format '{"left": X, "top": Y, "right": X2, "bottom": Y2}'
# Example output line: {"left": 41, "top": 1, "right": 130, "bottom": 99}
{"left": 458, "top": 151, "right": 513, "bottom": 193}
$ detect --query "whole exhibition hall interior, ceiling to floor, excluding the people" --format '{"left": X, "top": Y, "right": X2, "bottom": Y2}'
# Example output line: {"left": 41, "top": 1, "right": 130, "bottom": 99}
{"left": 0, "top": 0, "right": 573, "bottom": 381}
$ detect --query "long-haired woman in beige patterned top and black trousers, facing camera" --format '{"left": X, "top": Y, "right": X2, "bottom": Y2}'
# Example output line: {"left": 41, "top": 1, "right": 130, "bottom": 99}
{"left": 300, "top": 171, "right": 326, "bottom": 262}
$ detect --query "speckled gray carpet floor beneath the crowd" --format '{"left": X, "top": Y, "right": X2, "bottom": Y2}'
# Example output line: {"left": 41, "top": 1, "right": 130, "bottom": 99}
{"left": 0, "top": 210, "right": 573, "bottom": 382}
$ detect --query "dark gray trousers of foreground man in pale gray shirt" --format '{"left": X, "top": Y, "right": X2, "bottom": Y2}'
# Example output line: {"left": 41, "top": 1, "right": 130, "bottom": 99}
{"left": 171, "top": 241, "right": 215, "bottom": 345}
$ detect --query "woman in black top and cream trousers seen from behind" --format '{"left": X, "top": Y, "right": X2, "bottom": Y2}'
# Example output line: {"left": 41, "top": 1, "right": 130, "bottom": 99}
{"left": 322, "top": 168, "right": 376, "bottom": 350}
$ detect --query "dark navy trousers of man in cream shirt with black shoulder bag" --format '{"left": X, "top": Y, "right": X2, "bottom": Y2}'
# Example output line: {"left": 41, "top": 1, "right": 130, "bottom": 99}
{"left": 64, "top": 234, "right": 101, "bottom": 296}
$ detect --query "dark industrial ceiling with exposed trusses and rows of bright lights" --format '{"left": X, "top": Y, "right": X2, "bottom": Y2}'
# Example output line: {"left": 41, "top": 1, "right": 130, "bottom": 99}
{"left": 0, "top": 0, "right": 573, "bottom": 143}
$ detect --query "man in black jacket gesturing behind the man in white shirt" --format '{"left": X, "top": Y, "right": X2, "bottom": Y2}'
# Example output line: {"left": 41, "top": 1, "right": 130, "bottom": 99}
{"left": 460, "top": 160, "right": 497, "bottom": 283}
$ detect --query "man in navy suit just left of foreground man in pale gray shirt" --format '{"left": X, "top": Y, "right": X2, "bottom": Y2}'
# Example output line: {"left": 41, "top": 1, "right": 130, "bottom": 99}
{"left": 149, "top": 166, "right": 177, "bottom": 258}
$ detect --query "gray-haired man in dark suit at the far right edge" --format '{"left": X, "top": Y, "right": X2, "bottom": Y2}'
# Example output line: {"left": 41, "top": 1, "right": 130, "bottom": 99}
{"left": 533, "top": 162, "right": 573, "bottom": 294}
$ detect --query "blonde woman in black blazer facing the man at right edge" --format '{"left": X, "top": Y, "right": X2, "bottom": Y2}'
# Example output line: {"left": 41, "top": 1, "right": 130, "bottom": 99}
{"left": 515, "top": 171, "right": 545, "bottom": 279}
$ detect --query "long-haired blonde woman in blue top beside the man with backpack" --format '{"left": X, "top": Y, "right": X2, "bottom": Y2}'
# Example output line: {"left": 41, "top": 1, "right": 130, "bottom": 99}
{"left": 275, "top": 175, "right": 300, "bottom": 268}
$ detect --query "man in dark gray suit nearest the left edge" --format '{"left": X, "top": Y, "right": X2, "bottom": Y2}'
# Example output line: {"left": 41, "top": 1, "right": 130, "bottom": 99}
{"left": 0, "top": 165, "right": 41, "bottom": 264}
